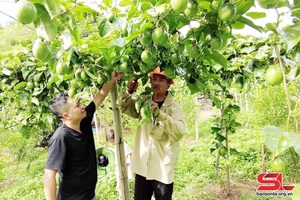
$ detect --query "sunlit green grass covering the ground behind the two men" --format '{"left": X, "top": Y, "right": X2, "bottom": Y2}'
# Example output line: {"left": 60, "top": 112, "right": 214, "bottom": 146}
{"left": 0, "top": 80, "right": 295, "bottom": 200}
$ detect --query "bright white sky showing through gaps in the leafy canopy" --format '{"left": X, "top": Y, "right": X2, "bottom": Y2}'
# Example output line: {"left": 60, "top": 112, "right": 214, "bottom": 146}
{"left": 0, "top": 0, "right": 291, "bottom": 36}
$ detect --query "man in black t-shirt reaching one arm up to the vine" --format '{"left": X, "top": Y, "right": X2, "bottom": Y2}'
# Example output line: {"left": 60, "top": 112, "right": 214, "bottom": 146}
{"left": 44, "top": 71, "right": 122, "bottom": 200}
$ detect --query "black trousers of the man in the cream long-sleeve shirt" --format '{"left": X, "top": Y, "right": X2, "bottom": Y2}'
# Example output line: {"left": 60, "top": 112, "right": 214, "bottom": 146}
{"left": 134, "top": 174, "right": 173, "bottom": 200}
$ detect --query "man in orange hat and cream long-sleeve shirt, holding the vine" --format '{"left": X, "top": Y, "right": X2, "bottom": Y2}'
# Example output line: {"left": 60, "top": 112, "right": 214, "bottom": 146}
{"left": 118, "top": 67, "right": 186, "bottom": 200}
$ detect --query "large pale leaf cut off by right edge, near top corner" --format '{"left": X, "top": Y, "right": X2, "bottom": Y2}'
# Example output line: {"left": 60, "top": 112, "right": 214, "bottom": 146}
{"left": 278, "top": 23, "right": 300, "bottom": 51}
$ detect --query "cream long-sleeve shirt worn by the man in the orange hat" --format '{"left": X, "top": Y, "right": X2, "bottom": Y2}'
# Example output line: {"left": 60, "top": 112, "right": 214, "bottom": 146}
{"left": 118, "top": 92, "right": 186, "bottom": 184}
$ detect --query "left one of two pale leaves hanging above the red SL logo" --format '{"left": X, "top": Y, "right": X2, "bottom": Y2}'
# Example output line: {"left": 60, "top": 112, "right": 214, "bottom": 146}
{"left": 263, "top": 126, "right": 283, "bottom": 154}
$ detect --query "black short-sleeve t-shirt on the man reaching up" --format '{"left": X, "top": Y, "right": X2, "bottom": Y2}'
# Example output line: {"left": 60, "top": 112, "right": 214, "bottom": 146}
{"left": 46, "top": 102, "right": 97, "bottom": 200}
